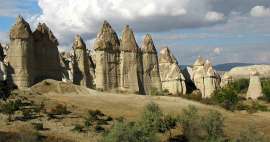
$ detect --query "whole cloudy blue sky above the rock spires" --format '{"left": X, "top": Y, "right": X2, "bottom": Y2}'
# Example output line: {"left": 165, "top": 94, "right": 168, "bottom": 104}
{"left": 0, "top": 0, "right": 270, "bottom": 64}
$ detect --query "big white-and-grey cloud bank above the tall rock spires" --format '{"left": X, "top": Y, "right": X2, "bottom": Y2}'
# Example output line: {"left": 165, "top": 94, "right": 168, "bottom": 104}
{"left": 32, "top": 0, "right": 224, "bottom": 44}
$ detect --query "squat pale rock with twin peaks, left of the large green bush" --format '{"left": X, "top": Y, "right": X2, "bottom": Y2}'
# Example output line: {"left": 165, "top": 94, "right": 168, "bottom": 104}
{"left": 191, "top": 57, "right": 220, "bottom": 98}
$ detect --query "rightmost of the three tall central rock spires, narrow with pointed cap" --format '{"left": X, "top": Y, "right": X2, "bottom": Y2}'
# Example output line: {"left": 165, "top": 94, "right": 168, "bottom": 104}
{"left": 141, "top": 34, "right": 162, "bottom": 94}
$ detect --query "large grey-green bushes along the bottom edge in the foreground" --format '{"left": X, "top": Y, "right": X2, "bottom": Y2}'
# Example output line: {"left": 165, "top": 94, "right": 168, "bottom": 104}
{"left": 101, "top": 103, "right": 267, "bottom": 142}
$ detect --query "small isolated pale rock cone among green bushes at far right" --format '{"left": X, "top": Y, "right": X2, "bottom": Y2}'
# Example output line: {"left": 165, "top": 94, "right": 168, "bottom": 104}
{"left": 246, "top": 70, "right": 263, "bottom": 100}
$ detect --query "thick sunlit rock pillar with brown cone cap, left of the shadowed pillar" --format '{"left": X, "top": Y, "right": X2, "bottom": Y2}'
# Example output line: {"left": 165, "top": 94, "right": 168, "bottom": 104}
{"left": 7, "top": 16, "right": 34, "bottom": 88}
